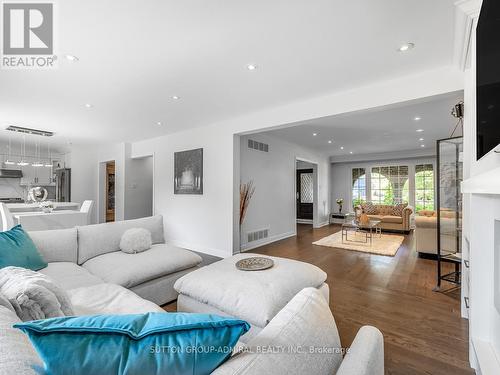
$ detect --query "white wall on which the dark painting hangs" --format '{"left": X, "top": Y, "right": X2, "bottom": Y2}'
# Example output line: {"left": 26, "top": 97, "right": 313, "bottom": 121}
{"left": 132, "top": 127, "right": 234, "bottom": 257}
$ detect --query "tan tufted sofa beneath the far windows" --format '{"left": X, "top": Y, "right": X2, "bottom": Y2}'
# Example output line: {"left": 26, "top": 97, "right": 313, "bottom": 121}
{"left": 359, "top": 204, "right": 414, "bottom": 232}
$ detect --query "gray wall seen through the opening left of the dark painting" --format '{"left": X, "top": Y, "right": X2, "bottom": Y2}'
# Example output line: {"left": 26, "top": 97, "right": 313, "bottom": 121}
{"left": 125, "top": 156, "right": 154, "bottom": 220}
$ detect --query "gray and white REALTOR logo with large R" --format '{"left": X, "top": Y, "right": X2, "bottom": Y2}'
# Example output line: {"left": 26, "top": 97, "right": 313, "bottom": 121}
{"left": 1, "top": 2, "right": 56, "bottom": 69}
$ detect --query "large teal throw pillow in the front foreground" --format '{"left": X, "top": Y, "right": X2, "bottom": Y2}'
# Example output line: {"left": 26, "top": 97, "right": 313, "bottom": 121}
{"left": 14, "top": 313, "right": 250, "bottom": 375}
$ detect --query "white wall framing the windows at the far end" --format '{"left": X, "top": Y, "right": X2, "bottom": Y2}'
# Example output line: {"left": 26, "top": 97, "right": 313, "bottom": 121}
{"left": 331, "top": 156, "right": 436, "bottom": 211}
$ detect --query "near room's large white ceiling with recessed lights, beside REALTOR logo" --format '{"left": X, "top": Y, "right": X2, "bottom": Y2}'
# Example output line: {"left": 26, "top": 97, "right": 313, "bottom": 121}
{"left": 0, "top": 0, "right": 454, "bottom": 147}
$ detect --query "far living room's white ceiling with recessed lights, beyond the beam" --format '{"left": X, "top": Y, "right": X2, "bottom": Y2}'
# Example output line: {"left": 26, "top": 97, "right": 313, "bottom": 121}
{"left": 265, "top": 92, "right": 463, "bottom": 158}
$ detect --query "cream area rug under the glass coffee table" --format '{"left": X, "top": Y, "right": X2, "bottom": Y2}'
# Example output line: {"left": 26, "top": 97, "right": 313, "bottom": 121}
{"left": 313, "top": 231, "right": 404, "bottom": 257}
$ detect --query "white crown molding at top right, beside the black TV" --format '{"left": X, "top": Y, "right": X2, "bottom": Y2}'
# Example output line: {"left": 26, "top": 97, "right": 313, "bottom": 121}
{"left": 453, "top": 0, "right": 483, "bottom": 70}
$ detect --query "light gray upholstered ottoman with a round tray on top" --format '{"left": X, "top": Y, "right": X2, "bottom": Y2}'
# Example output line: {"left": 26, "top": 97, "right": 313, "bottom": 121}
{"left": 174, "top": 253, "right": 329, "bottom": 341}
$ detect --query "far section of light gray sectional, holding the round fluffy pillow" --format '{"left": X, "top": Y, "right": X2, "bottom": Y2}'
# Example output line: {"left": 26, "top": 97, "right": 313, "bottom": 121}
{"left": 29, "top": 215, "right": 202, "bottom": 305}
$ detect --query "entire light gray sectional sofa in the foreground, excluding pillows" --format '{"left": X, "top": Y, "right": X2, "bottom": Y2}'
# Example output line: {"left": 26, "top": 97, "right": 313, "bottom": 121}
{"left": 0, "top": 216, "right": 384, "bottom": 375}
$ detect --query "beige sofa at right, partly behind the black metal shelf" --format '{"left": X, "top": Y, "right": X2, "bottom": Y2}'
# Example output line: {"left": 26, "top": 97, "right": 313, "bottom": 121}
{"left": 415, "top": 210, "right": 457, "bottom": 254}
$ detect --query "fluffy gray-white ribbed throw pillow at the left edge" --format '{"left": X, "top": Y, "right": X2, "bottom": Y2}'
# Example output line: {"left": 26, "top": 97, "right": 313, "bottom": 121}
{"left": 0, "top": 267, "right": 73, "bottom": 321}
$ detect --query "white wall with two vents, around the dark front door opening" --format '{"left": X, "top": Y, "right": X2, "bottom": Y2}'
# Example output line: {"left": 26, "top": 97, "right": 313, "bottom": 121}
{"left": 240, "top": 133, "right": 329, "bottom": 250}
